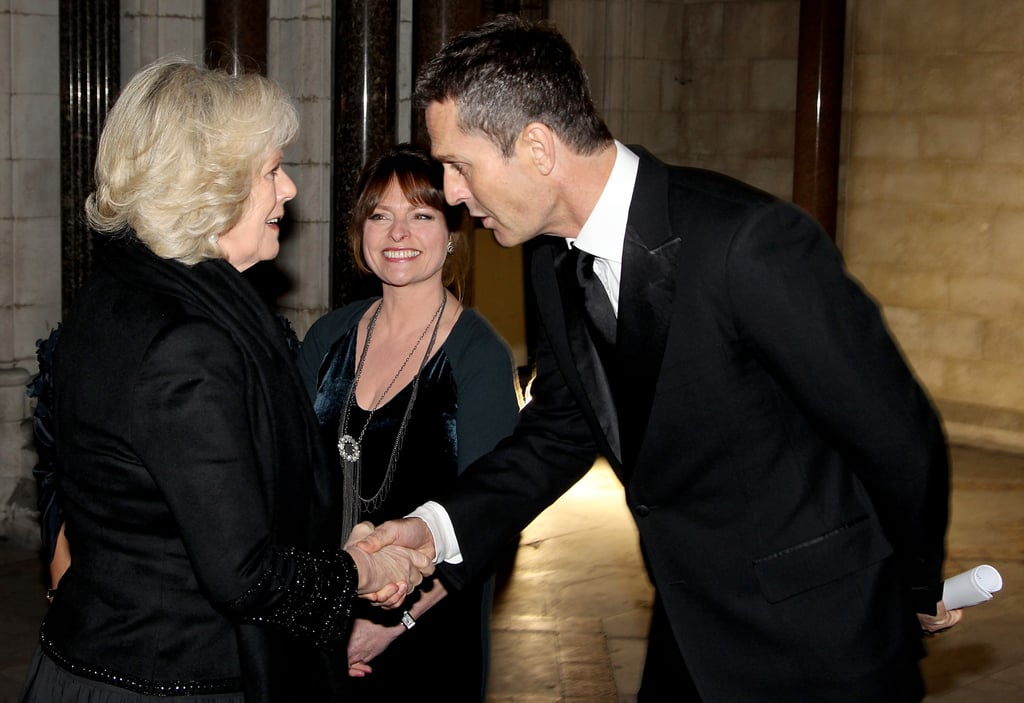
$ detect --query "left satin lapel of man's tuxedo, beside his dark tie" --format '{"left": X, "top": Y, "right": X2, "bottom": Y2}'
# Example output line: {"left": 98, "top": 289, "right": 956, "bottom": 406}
{"left": 534, "top": 240, "right": 622, "bottom": 463}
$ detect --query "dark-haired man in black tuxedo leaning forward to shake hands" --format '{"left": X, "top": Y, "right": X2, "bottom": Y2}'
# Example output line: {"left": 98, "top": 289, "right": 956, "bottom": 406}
{"left": 364, "top": 17, "right": 961, "bottom": 703}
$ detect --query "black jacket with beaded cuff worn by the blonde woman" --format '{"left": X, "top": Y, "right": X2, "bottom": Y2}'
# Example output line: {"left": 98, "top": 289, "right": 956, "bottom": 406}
{"left": 42, "top": 237, "right": 356, "bottom": 701}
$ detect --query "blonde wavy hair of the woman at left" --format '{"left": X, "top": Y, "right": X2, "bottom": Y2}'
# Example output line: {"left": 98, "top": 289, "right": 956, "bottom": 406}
{"left": 85, "top": 56, "right": 299, "bottom": 264}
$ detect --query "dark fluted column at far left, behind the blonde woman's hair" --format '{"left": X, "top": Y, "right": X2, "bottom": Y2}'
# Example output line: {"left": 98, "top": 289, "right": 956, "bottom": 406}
{"left": 58, "top": 0, "right": 121, "bottom": 314}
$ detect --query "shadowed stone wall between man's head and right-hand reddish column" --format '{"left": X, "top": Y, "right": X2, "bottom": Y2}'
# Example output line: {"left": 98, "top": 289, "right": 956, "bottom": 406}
{"left": 549, "top": 0, "right": 800, "bottom": 197}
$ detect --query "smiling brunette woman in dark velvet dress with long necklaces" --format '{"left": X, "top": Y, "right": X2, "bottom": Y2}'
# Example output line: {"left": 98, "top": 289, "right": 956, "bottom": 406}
{"left": 299, "top": 144, "right": 518, "bottom": 701}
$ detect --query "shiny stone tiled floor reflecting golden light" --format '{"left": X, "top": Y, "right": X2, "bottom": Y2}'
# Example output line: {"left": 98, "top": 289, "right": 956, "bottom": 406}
{"left": 0, "top": 448, "right": 1024, "bottom": 703}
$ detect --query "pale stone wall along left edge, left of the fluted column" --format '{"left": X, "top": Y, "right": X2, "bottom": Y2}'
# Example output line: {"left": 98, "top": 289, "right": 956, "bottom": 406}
{"left": 0, "top": 0, "right": 60, "bottom": 542}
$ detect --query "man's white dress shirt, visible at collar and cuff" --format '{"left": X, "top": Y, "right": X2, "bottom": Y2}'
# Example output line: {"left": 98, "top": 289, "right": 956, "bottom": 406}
{"left": 409, "top": 140, "right": 640, "bottom": 564}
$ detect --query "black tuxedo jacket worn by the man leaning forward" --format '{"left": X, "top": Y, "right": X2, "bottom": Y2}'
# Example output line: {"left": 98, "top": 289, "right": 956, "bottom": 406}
{"left": 444, "top": 149, "right": 948, "bottom": 701}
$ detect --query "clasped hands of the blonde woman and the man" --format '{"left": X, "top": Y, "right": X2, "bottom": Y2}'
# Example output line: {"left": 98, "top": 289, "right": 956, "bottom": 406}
{"left": 344, "top": 518, "right": 435, "bottom": 608}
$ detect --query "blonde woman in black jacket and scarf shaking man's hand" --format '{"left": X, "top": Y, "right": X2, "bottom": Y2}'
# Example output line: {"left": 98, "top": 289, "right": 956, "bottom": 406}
{"left": 22, "top": 58, "right": 432, "bottom": 703}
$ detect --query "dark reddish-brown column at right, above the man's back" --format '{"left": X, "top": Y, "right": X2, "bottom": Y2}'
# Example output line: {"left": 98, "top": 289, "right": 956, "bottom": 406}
{"left": 793, "top": 0, "right": 846, "bottom": 240}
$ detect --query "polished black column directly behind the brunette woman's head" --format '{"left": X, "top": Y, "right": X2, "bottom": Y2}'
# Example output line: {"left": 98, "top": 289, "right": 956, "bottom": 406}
{"left": 330, "top": 0, "right": 395, "bottom": 309}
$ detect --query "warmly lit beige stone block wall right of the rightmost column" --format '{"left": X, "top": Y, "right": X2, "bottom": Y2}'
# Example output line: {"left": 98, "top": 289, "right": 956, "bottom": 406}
{"left": 841, "top": 0, "right": 1024, "bottom": 450}
